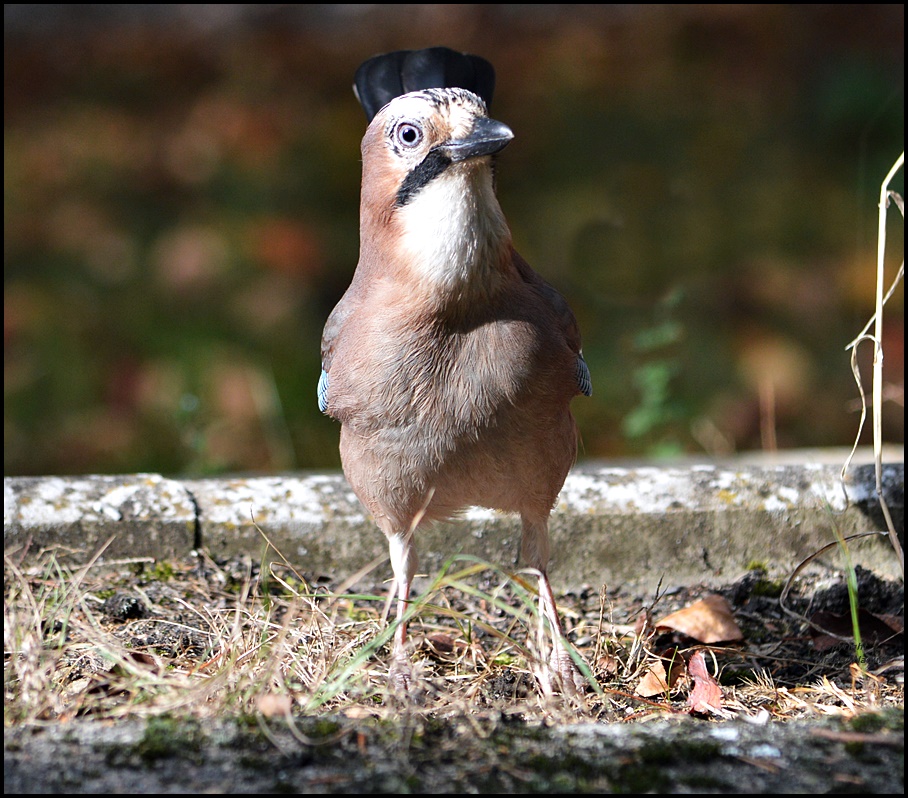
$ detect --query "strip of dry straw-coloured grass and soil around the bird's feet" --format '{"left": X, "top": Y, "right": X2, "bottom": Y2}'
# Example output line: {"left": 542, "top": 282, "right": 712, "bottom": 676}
{"left": 4, "top": 540, "right": 904, "bottom": 726}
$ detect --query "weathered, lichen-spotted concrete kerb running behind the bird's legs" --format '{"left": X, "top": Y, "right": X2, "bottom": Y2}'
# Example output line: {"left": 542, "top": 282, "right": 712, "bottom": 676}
{"left": 3, "top": 462, "right": 905, "bottom": 590}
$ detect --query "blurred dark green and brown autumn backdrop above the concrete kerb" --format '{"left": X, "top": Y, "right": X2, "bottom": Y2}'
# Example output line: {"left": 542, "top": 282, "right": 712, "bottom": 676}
{"left": 4, "top": 4, "right": 904, "bottom": 475}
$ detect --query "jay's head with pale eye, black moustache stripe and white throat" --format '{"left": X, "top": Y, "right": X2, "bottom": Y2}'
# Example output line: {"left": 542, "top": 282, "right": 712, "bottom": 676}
{"left": 361, "top": 88, "right": 514, "bottom": 296}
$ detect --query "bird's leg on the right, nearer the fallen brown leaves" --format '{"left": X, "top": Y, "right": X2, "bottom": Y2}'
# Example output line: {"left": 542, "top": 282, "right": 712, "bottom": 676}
{"left": 521, "top": 516, "right": 583, "bottom": 695}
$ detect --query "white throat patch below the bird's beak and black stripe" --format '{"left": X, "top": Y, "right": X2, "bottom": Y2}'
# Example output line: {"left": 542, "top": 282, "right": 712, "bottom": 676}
{"left": 398, "top": 165, "right": 507, "bottom": 289}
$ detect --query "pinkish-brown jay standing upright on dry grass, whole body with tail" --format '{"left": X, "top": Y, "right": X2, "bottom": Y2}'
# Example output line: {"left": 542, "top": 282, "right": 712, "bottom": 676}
{"left": 318, "top": 47, "right": 592, "bottom": 694}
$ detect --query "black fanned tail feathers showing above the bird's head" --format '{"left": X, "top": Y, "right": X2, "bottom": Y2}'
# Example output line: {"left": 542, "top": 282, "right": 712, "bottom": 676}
{"left": 353, "top": 47, "right": 495, "bottom": 122}
